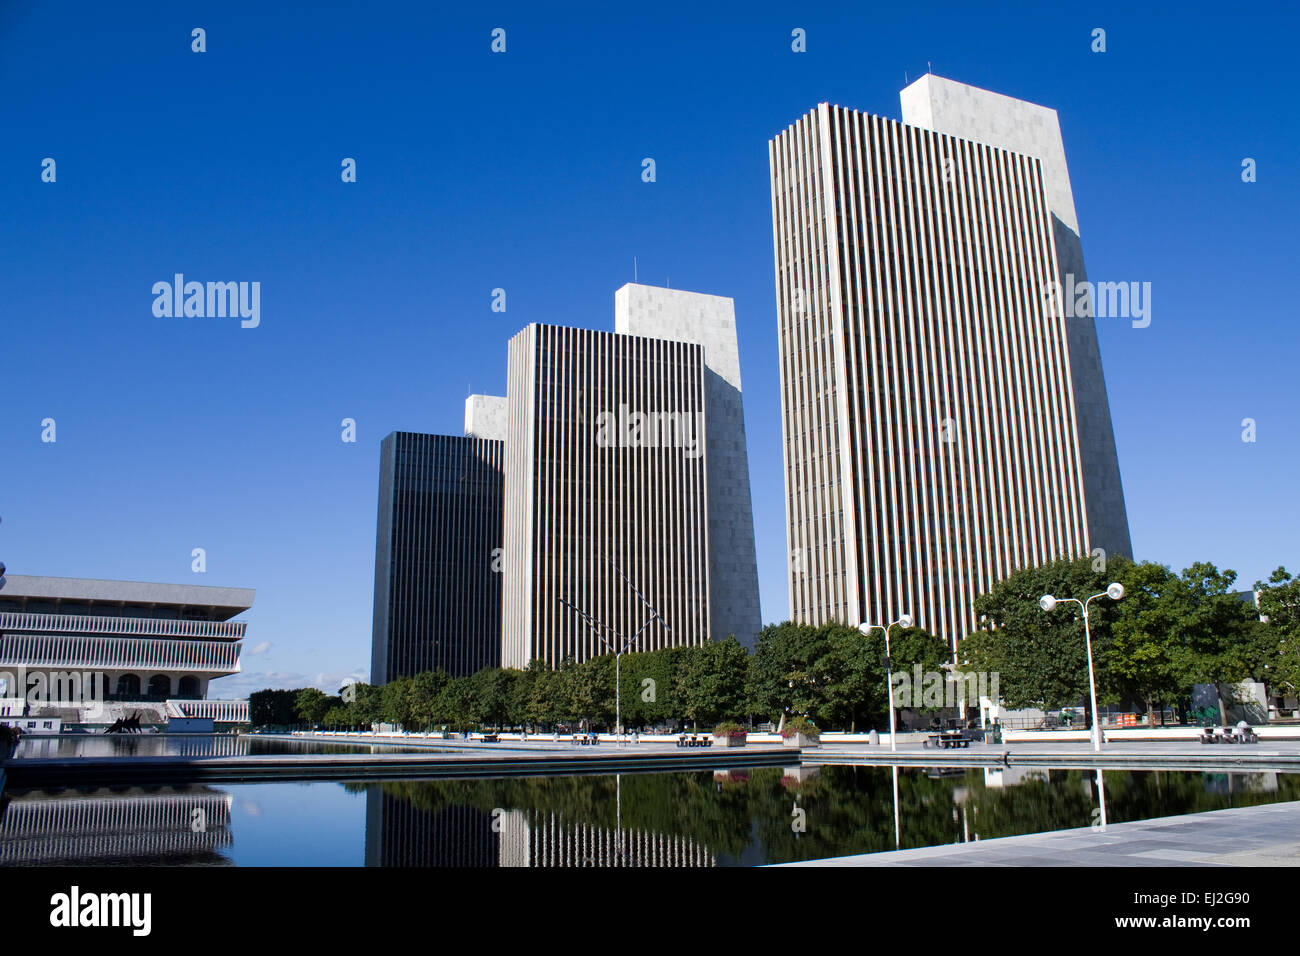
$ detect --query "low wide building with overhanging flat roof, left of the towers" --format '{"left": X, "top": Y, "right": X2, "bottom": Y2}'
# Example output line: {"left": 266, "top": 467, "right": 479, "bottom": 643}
{"left": 0, "top": 575, "right": 255, "bottom": 730}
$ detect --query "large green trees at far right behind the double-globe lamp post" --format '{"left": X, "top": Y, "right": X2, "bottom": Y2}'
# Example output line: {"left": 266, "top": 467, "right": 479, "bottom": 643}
{"left": 958, "top": 558, "right": 1300, "bottom": 719}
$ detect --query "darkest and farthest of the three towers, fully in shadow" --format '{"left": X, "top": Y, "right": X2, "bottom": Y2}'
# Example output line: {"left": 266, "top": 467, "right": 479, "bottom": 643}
{"left": 371, "top": 426, "right": 503, "bottom": 684}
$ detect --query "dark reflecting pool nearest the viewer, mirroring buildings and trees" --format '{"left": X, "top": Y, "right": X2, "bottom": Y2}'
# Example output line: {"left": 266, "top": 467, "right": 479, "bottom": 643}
{"left": 0, "top": 764, "right": 1300, "bottom": 866}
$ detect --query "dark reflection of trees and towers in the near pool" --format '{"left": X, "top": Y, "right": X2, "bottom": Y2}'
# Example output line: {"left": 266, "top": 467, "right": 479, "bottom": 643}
{"left": 356, "top": 765, "right": 1300, "bottom": 866}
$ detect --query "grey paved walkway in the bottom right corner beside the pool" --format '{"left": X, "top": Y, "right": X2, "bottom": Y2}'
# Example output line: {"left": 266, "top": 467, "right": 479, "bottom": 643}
{"left": 784, "top": 803, "right": 1300, "bottom": 866}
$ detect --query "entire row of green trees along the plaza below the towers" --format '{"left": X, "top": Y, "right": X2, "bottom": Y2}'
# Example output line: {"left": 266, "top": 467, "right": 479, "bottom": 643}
{"left": 251, "top": 558, "right": 1300, "bottom": 731}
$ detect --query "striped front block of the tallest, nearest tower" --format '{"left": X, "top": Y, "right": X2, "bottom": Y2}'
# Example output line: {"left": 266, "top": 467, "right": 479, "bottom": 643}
{"left": 770, "top": 80, "right": 1127, "bottom": 646}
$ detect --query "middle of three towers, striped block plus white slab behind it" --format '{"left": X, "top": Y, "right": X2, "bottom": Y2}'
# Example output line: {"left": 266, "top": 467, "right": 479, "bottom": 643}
{"left": 502, "top": 284, "right": 761, "bottom": 667}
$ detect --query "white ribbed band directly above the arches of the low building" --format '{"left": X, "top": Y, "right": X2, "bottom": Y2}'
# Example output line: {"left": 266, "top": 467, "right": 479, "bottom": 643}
{"left": 0, "top": 633, "right": 243, "bottom": 674}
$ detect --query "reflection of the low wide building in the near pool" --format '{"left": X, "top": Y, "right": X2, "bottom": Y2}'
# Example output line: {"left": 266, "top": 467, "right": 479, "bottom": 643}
{"left": 0, "top": 787, "right": 231, "bottom": 866}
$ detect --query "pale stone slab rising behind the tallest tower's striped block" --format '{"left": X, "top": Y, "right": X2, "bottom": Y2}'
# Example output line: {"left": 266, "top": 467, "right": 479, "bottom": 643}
{"left": 900, "top": 80, "right": 1132, "bottom": 567}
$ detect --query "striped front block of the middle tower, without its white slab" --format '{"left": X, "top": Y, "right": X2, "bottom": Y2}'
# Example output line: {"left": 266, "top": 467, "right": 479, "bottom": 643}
{"left": 502, "top": 325, "right": 710, "bottom": 667}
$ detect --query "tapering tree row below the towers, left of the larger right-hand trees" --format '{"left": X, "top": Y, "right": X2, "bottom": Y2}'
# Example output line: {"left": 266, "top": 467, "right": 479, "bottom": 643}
{"left": 250, "top": 623, "right": 945, "bottom": 731}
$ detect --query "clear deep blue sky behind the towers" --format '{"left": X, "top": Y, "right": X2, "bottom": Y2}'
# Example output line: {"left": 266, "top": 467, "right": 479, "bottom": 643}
{"left": 0, "top": 3, "right": 1300, "bottom": 696}
